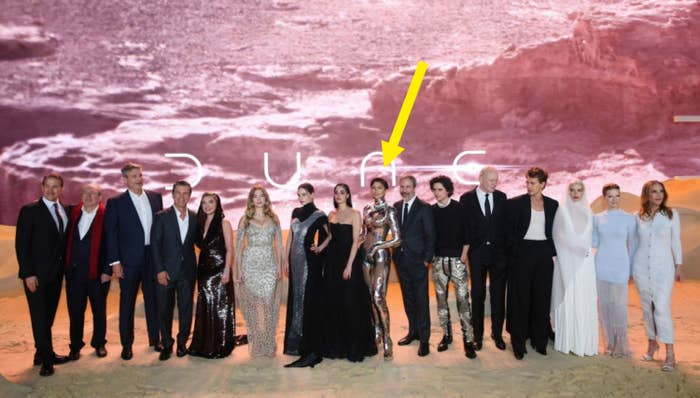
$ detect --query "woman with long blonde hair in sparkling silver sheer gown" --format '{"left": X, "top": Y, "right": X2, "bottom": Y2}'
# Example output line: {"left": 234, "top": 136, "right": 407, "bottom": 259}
{"left": 233, "top": 185, "right": 283, "bottom": 357}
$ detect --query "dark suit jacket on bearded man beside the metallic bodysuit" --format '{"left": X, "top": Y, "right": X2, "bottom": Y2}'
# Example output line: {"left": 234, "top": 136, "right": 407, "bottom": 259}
{"left": 394, "top": 197, "right": 435, "bottom": 262}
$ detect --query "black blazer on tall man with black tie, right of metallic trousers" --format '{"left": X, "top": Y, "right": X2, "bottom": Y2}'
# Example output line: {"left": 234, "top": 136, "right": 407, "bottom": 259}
{"left": 459, "top": 188, "right": 507, "bottom": 253}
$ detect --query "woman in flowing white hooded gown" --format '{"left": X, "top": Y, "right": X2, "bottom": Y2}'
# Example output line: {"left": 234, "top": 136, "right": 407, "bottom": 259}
{"left": 551, "top": 180, "right": 598, "bottom": 356}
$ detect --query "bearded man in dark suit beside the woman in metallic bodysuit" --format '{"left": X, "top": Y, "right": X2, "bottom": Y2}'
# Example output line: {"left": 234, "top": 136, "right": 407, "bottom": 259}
{"left": 394, "top": 175, "right": 435, "bottom": 356}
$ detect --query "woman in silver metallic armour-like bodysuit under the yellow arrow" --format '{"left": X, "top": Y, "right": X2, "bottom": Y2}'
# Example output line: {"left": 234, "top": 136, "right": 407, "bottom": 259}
{"left": 362, "top": 177, "right": 401, "bottom": 359}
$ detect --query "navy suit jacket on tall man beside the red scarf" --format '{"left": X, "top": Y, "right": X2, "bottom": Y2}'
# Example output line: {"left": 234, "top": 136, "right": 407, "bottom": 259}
{"left": 104, "top": 191, "right": 163, "bottom": 272}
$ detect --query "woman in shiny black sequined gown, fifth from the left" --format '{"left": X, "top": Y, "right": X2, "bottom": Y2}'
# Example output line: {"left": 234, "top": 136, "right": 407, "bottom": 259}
{"left": 189, "top": 192, "right": 236, "bottom": 358}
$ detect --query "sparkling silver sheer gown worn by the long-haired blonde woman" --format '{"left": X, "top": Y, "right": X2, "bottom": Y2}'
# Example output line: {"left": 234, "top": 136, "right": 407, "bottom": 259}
{"left": 236, "top": 222, "right": 282, "bottom": 357}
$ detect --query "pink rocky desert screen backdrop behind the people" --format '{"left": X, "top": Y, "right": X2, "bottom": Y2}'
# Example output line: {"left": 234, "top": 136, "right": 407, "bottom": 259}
{"left": 0, "top": 0, "right": 700, "bottom": 225}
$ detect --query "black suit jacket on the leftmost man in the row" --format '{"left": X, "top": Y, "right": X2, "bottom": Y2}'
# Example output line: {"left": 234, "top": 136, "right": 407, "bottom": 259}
{"left": 15, "top": 198, "right": 70, "bottom": 284}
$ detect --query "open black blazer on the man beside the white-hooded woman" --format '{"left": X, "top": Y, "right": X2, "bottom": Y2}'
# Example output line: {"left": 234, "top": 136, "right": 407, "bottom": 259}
{"left": 508, "top": 194, "right": 559, "bottom": 256}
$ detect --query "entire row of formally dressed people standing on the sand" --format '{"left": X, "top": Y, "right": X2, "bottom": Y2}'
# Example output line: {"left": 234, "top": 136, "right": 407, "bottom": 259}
{"left": 16, "top": 164, "right": 681, "bottom": 374}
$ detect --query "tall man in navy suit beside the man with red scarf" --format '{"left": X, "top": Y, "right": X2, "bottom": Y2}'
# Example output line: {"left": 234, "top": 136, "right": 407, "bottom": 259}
{"left": 105, "top": 163, "right": 163, "bottom": 360}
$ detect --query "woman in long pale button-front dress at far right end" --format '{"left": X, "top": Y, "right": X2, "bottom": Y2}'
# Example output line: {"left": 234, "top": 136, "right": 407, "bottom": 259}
{"left": 632, "top": 181, "right": 683, "bottom": 372}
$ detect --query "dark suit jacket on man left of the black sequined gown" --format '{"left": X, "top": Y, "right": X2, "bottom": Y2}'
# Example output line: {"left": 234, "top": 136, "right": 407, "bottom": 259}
{"left": 151, "top": 207, "right": 199, "bottom": 281}
